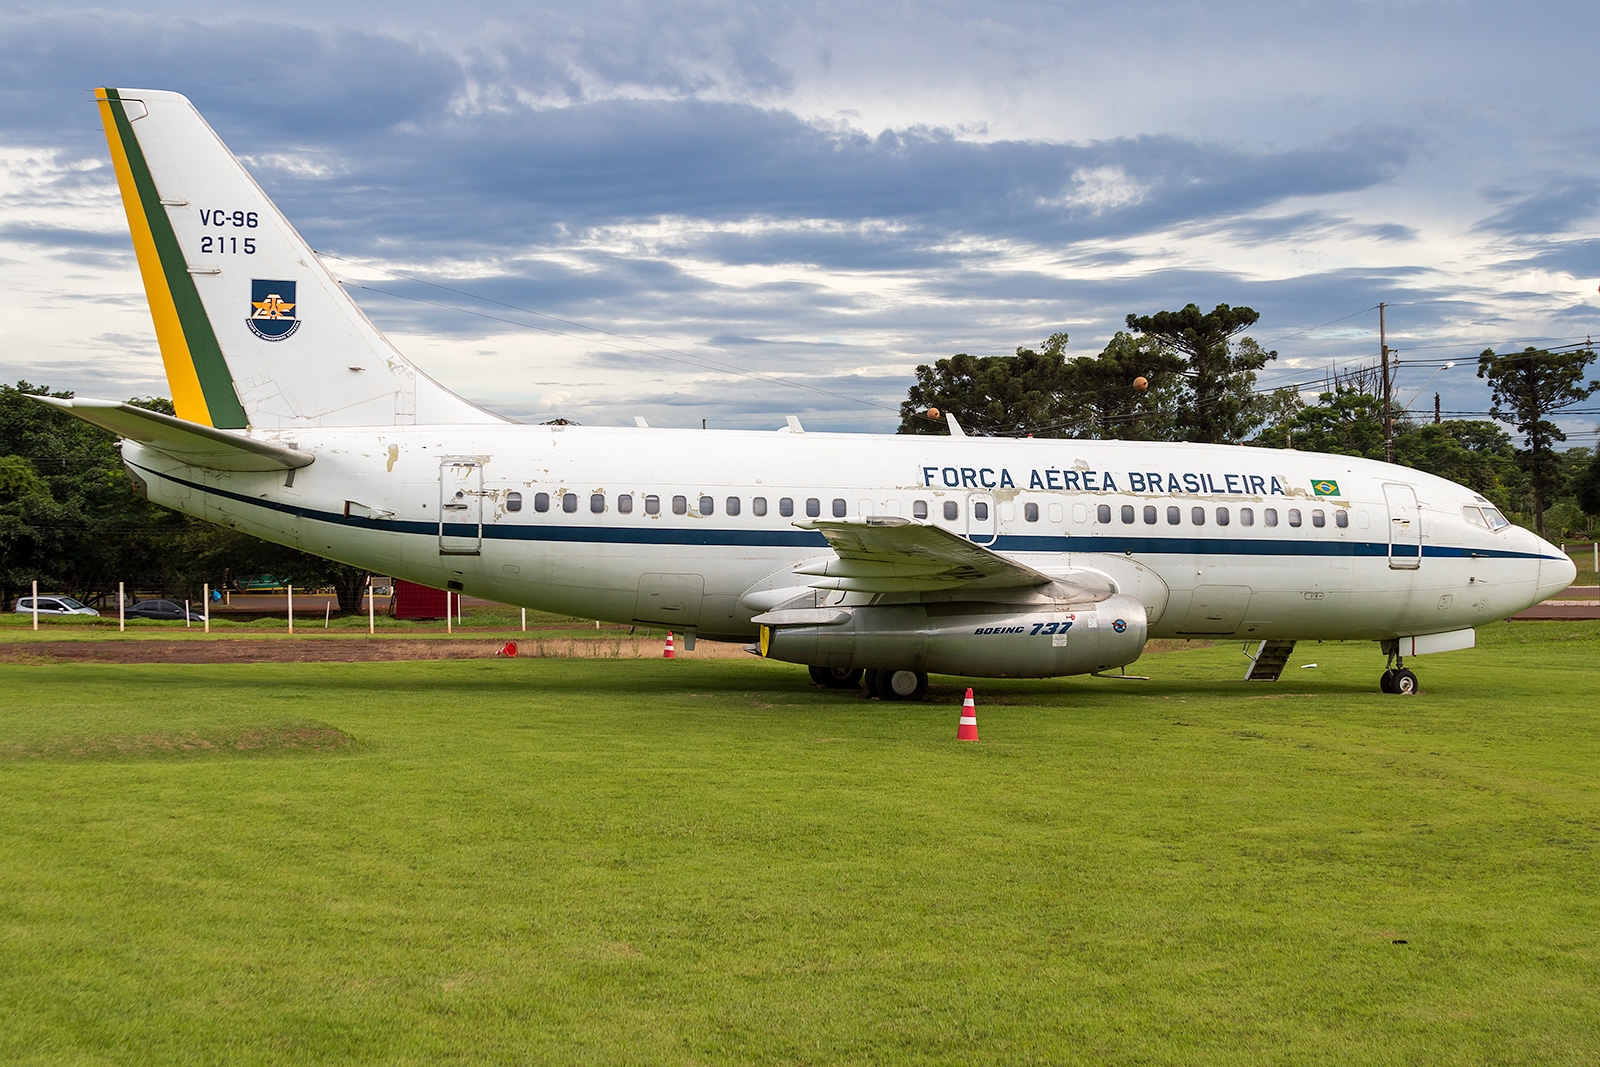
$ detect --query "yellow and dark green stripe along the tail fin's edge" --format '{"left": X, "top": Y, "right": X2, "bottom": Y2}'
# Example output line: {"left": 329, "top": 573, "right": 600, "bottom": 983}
{"left": 94, "top": 90, "right": 248, "bottom": 429}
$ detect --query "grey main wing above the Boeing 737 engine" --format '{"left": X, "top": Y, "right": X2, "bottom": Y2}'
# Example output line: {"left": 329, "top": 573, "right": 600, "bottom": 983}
{"left": 795, "top": 518, "right": 1056, "bottom": 593}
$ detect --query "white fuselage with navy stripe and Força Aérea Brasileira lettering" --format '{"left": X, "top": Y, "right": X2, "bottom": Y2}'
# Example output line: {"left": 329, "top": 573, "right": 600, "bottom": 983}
{"left": 123, "top": 424, "right": 1573, "bottom": 640}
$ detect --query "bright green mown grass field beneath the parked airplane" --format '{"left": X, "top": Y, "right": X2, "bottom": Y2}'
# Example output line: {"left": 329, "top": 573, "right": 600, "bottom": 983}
{"left": 0, "top": 622, "right": 1600, "bottom": 1064}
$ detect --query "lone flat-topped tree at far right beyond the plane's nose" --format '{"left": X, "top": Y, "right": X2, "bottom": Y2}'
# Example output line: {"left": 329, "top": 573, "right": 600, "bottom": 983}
{"left": 1478, "top": 347, "right": 1600, "bottom": 537}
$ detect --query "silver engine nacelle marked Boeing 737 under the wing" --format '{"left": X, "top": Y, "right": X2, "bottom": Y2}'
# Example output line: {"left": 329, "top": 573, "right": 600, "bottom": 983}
{"left": 755, "top": 595, "right": 1147, "bottom": 678}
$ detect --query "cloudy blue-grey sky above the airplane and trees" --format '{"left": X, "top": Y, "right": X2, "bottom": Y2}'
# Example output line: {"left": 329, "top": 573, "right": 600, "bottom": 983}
{"left": 0, "top": 0, "right": 1600, "bottom": 443}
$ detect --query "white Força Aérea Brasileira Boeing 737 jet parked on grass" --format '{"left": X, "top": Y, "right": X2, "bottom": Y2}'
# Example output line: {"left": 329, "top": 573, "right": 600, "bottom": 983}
{"left": 37, "top": 88, "right": 1576, "bottom": 699}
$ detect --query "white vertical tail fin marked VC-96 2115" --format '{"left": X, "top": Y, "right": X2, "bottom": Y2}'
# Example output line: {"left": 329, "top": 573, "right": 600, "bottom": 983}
{"left": 94, "top": 90, "right": 504, "bottom": 429}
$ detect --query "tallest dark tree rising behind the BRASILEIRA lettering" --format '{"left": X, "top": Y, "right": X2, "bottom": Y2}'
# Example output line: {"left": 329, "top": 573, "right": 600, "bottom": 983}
{"left": 1128, "top": 304, "right": 1278, "bottom": 443}
